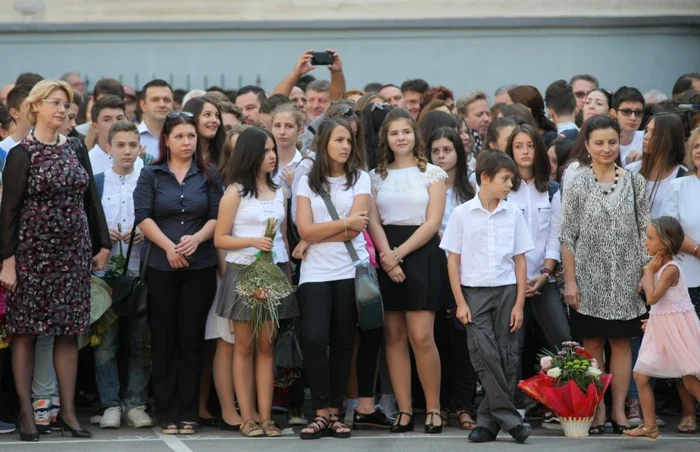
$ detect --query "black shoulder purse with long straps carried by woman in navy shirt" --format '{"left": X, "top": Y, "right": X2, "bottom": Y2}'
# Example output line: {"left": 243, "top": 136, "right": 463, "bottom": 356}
{"left": 112, "top": 176, "right": 158, "bottom": 317}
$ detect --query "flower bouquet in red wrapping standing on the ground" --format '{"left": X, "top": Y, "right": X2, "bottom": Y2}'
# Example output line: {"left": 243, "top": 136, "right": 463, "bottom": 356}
{"left": 518, "top": 342, "right": 612, "bottom": 436}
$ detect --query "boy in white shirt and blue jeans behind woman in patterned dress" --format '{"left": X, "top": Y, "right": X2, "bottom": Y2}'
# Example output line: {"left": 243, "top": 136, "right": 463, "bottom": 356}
{"left": 90, "top": 121, "right": 153, "bottom": 428}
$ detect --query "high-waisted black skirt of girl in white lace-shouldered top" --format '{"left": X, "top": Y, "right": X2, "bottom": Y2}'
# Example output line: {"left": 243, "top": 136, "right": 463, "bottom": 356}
{"left": 377, "top": 225, "right": 454, "bottom": 311}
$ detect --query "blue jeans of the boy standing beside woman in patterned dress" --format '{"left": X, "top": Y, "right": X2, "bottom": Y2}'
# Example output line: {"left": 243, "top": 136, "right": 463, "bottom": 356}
{"left": 95, "top": 315, "right": 151, "bottom": 412}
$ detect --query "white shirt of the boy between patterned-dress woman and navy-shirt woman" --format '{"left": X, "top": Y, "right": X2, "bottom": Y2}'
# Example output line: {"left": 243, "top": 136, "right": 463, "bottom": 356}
{"left": 102, "top": 168, "right": 143, "bottom": 274}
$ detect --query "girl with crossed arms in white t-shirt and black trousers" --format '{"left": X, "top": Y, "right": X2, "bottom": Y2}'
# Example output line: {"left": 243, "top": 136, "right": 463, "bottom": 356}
{"left": 296, "top": 118, "right": 371, "bottom": 439}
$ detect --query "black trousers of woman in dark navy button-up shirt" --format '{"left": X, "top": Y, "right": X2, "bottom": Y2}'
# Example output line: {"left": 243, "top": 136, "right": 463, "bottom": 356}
{"left": 146, "top": 267, "right": 216, "bottom": 426}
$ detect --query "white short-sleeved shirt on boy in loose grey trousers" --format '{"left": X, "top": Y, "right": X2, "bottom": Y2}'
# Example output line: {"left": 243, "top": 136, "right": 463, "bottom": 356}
{"left": 440, "top": 196, "right": 534, "bottom": 287}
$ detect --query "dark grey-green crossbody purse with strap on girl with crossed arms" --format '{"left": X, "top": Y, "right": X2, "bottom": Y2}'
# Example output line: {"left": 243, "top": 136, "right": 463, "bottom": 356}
{"left": 321, "top": 194, "right": 384, "bottom": 330}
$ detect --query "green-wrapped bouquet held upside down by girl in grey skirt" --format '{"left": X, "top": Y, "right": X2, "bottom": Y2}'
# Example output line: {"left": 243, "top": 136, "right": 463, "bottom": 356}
{"left": 236, "top": 218, "right": 294, "bottom": 337}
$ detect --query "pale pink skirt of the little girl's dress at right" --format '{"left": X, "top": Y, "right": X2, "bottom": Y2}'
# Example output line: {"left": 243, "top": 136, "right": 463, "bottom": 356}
{"left": 634, "top": 310, "right": 700, "bottom": 378}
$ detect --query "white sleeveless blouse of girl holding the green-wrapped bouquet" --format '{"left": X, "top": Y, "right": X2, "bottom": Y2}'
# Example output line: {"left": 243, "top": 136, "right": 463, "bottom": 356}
{"left": 226, "top": 186, "right": 289, "bottom": 265}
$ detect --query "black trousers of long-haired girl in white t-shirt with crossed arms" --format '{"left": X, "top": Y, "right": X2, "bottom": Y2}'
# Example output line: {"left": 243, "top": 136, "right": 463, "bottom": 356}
{"left": 299, "top": 279, "right": 357, "bottom": 410}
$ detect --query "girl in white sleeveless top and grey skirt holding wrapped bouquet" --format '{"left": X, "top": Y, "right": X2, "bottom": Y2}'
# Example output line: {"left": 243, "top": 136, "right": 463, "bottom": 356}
{"left": 214, "top": 127, "right": 298, "bottom": 437}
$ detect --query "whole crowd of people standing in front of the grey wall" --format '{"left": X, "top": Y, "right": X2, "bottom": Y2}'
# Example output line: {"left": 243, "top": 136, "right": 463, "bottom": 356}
{"left": 0, "top": 50, "right": 700, "bottom": 443}
